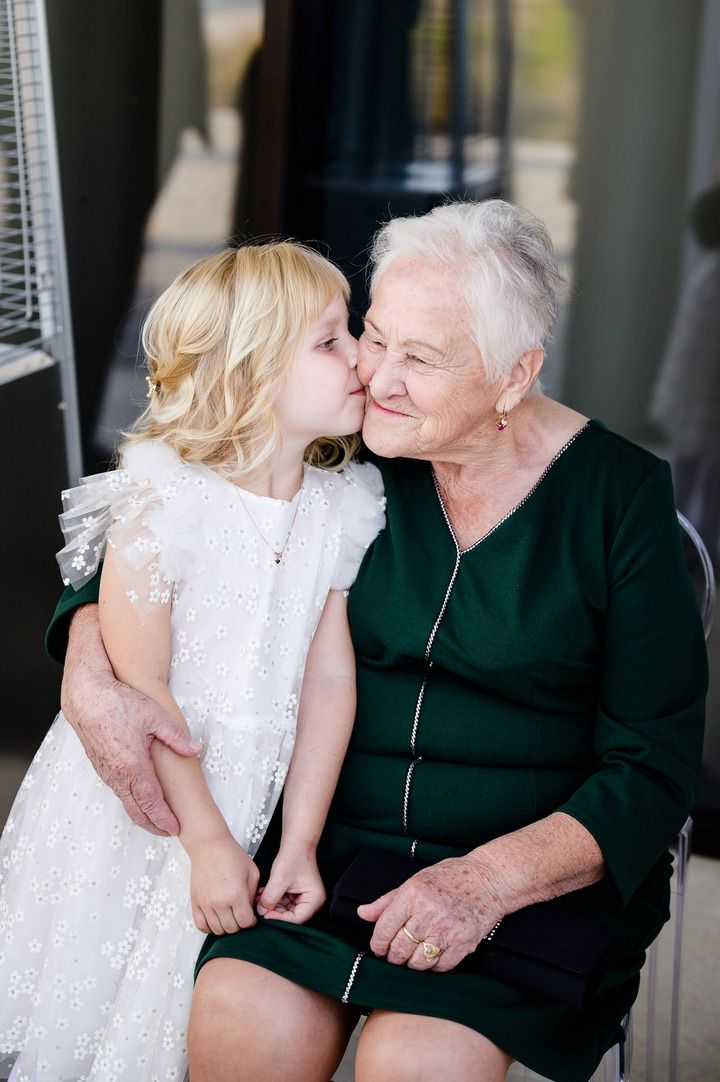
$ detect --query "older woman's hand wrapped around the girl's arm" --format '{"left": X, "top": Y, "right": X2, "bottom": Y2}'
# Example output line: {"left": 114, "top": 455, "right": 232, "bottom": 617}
{"left": 61, "top": 605, "right": 201, "bottom": 835}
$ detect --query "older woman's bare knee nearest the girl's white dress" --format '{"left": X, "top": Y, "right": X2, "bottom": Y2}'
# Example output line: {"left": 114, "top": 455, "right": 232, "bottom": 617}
{"left": 187, "top": 958, "right": 359, "bottom": 1082}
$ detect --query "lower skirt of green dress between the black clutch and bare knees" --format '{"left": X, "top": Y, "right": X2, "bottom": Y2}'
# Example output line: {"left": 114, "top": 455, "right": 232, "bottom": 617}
{"left": 193, "top": 919, "right": 634, "bottom": 1082}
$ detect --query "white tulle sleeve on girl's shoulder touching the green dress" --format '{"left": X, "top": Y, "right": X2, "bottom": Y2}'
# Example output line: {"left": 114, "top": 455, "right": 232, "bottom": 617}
{"left": 330, "top": 462, "right": 385, "bottom": 590}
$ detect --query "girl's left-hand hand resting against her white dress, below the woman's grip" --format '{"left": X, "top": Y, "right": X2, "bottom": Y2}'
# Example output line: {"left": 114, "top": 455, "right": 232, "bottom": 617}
{"left": 191, "top": 835, "right": 260, "bottom": 936}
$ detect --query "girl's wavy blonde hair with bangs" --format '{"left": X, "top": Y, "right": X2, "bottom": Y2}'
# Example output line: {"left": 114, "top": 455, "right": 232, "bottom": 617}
{"left": 120, "top": 240, "right": 359, "bottom": 480}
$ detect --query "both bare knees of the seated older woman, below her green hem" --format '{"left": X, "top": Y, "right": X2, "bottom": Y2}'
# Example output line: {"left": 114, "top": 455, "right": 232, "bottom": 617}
{"left": 188, "top": 958, "right": 512, "bottom": 1082}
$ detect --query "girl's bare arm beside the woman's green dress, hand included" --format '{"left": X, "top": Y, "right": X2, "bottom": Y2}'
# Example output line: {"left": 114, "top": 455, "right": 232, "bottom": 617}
{"left": 258, "top": 590, "right": 355, "bottom": 924}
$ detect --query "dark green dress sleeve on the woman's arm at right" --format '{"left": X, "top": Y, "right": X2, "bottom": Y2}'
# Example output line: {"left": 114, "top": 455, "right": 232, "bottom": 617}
{"left": 559, "top": 462, "right": 707, "bottom": 903}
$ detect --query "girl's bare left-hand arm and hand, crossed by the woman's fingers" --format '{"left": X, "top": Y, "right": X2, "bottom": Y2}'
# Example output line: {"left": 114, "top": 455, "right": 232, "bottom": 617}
{"left": 100, "top": 547, "right": 259, "bottom": 935}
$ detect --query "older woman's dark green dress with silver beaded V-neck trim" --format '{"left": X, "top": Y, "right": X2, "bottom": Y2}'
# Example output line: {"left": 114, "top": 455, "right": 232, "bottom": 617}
{"left": 47, "top": 421, "right": 707, "bottom": 1082}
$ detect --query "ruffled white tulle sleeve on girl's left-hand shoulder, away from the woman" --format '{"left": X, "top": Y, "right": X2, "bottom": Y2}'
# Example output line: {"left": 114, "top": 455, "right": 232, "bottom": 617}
{"left": 57, "top": 440, "right": 207, "bottom": 621}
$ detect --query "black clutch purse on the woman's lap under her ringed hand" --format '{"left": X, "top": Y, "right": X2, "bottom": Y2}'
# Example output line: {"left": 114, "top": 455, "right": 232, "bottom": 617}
{"left": 330, "top": 846, "right": 616, "bottom": 1010}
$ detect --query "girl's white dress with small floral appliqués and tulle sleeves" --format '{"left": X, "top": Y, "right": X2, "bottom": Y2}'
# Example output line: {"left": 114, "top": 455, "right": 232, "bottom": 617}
{"left": 0, "top": 441, "right": 384, "bottom": 1082}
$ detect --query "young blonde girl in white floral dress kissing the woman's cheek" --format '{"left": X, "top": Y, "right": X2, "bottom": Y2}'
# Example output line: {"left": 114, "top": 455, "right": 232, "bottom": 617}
{"left": 0, "top": 242, "right": 383, "bottom": 1082}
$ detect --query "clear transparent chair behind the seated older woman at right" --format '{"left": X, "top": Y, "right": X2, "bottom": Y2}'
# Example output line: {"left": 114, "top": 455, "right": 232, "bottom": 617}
{"left": 591, "top": 512, "right": 716, "bottom": 1082}
